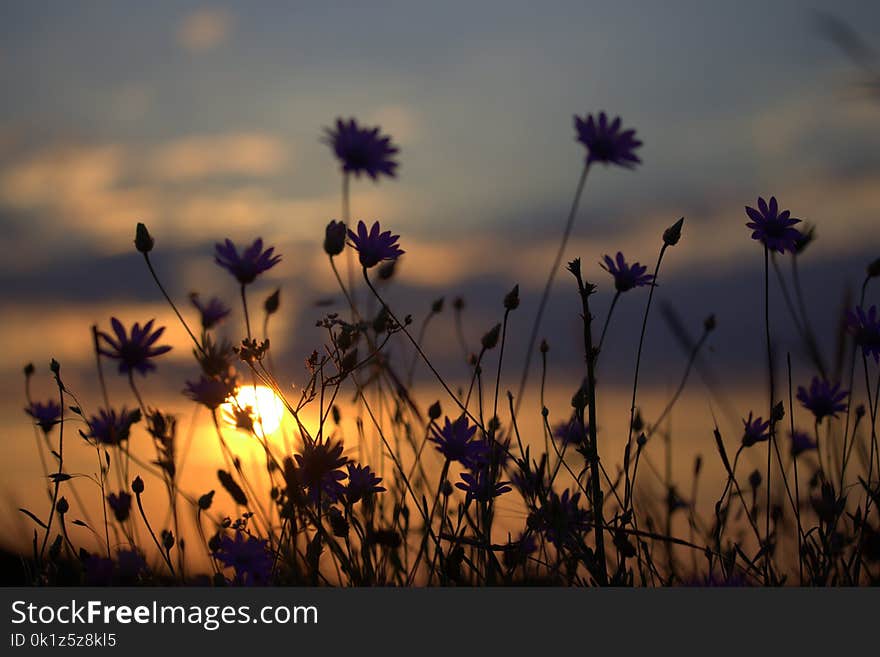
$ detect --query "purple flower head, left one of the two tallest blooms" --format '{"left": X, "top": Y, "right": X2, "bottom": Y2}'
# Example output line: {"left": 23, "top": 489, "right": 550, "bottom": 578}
{"left": 324, "top": 118, "right": 398, "bottom": 180}
